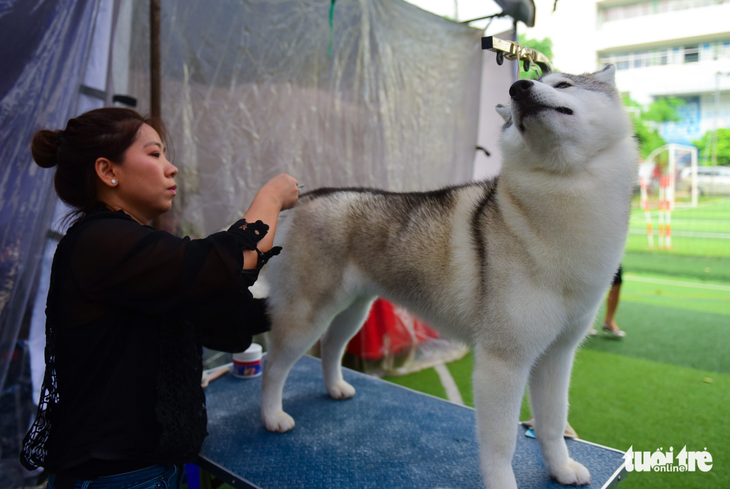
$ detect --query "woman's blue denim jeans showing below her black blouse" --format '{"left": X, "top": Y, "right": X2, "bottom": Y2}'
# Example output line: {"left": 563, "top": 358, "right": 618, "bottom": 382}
{"left": 48, "top": 465, "right": 184, "bottom": 489}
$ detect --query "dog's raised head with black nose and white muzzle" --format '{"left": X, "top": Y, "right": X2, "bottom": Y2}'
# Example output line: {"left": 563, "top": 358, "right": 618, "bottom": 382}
{"left": 497, "top": 65, "right": 630, "bottom": 171}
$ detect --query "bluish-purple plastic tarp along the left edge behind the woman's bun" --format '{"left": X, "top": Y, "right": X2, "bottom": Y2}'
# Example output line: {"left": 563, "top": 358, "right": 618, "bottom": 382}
{"left": 0, "top": 0, "right": 98, "bottom": 400}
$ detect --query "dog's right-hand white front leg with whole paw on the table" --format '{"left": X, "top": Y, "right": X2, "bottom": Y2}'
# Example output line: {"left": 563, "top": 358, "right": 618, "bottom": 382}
{"left": 530, "top": 332, "right": 591, "bottom": 485}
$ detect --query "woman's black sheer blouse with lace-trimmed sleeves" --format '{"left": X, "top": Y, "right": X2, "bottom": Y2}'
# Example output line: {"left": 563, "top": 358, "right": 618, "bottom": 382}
{"left": 21, "top": 211, "right": 278, "bottom": 479}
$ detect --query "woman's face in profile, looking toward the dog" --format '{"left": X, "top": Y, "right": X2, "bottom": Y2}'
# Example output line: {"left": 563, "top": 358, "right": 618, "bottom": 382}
{"left": 116, "top": 124, "right": 177, "bottom": 224}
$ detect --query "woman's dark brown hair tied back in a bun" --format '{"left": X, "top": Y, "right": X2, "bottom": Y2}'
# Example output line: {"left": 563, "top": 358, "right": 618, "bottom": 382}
{"left": 31, "top": 107, "right": 165, "bottom": 216}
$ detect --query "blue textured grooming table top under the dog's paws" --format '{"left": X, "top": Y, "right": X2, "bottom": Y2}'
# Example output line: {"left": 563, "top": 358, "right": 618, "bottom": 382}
{"left": 197, "top": 356, "right": 625, "bottom": 489}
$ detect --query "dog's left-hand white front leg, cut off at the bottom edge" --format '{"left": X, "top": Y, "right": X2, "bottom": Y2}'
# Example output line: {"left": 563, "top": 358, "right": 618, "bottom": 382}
{"left": 474, "top": 346, "right": 531, "bottom": 489}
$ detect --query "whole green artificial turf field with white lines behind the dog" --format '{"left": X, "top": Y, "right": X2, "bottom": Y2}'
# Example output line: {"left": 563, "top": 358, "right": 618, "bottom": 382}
{"left": 386, "top": 198, "right": 730, "bottom": 489}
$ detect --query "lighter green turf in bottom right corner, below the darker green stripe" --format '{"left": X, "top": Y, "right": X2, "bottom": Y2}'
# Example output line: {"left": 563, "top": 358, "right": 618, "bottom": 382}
{"left": 569, "top": 349, "right": 730, "bottom": 489}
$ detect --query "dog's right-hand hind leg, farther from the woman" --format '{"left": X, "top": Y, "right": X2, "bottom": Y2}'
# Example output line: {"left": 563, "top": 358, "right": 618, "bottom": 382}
{"left": 320, "top": 296, "right": 375, "bottom": 399}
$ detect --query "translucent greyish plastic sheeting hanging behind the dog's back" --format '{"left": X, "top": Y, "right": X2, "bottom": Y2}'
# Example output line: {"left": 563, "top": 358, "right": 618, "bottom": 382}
{"left": 123, "top": 0, "right": 482, "bottom": 236}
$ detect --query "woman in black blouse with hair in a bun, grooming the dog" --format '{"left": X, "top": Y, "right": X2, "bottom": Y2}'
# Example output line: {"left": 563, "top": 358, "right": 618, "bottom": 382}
{"left": 21, "top": 108, "right": 298, "bottom": 489}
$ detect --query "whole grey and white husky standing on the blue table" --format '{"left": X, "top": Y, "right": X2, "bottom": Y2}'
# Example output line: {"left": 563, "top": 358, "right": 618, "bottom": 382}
{"left": 261, "top": 66, "right": 638, "bottom": 489}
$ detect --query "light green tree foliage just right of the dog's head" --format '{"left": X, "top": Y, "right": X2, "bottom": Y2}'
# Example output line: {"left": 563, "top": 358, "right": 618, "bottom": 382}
{"left": 623, "top": 96, "right": 685, "bottom": 163}
